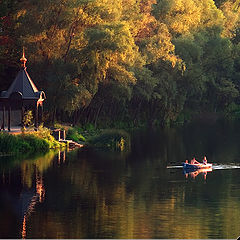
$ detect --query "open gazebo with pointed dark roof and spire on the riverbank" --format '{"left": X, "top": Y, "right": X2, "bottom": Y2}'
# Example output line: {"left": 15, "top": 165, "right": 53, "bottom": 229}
{"left": 0, "top": 51, "right": 46, "bottom": 131}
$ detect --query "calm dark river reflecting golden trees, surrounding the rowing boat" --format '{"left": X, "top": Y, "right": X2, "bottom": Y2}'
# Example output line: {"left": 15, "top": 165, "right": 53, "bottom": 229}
{"left": 0, "top": 123, "right": 240, "bottom": 239}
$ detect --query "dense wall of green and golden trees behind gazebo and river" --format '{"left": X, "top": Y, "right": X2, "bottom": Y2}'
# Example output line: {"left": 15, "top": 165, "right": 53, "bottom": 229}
{"left": 0, "top": 0, "right": 240, "bottom": 127}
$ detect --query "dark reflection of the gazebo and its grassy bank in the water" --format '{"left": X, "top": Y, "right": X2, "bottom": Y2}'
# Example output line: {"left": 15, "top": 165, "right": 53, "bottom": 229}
{"left": 0, "top": 152, "right": 58, "bottom": 239}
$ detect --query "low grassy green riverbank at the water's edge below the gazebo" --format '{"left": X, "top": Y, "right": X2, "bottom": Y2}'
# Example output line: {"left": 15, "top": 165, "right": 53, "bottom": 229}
{"left": 0, "top": 125, "right": 130, "bottom": 156}
